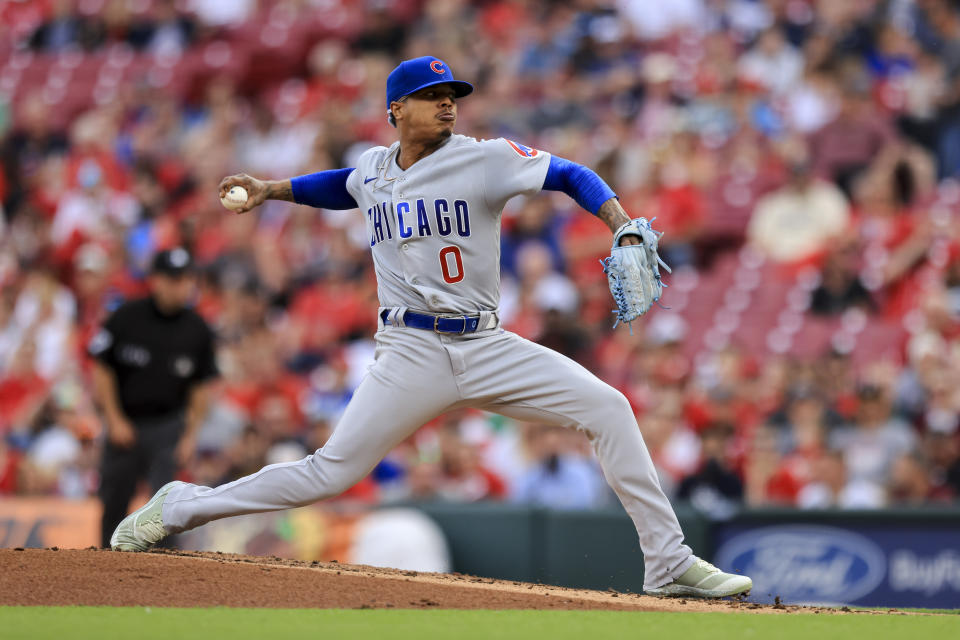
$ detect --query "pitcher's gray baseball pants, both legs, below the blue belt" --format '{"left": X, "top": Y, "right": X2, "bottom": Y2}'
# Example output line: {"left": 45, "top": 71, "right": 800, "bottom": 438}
{"left": 163, "top": 323, "right": 693, "bottom": 588}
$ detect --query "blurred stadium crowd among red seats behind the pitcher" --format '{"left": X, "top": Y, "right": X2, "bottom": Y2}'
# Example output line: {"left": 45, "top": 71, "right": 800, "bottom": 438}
{"left": 0, "top": 0, "right": 960, "bottom": 516}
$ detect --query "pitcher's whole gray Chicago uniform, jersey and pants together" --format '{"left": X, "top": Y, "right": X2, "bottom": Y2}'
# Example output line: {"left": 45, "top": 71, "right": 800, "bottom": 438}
{"left": 162, "top": 135, "right": 694, "bottom": 588}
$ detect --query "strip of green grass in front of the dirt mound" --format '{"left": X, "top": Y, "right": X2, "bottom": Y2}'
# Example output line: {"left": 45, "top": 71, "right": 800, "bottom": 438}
{"left": 0, "top": 607, "right": 960, "bottom": 640}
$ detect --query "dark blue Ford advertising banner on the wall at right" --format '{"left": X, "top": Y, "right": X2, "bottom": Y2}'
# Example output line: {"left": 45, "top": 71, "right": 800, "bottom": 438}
{"left": 714, "top": 523, "right": 960, "bottom": 608}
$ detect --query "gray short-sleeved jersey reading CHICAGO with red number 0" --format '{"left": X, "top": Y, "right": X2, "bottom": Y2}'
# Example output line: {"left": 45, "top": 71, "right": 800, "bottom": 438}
{"left": 347, "top": 135, "right": 550, "bottom": 313}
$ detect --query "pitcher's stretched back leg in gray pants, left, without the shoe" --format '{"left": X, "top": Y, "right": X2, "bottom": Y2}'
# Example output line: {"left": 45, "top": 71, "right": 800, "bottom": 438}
{"left": 163, "top": 329, "right": 459, "bottom": 533}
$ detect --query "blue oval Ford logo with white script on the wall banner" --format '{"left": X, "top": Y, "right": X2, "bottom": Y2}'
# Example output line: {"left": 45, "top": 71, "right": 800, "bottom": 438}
{"left": 716, "top": 525, "right": 887, "bottom": 604}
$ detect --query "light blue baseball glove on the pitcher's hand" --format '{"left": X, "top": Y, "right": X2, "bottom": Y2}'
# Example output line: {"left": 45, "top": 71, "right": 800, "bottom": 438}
{"left": 600, "top": 218, "right": 670, "bottom": 333}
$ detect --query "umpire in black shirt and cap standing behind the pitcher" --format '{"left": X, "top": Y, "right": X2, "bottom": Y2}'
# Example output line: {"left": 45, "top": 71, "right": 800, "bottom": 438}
{"left": 88, "top": 248, "right": 217, "bottom": 547}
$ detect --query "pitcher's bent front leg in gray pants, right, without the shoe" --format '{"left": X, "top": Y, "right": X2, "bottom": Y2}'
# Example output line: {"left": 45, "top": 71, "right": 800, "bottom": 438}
{"left": 465, "top": 334, "right": 693, "bottom": 588}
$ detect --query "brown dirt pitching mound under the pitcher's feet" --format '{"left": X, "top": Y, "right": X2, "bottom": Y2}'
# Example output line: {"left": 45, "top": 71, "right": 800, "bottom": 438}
{"left": 0, "top": 548, "right": 836, "bottom": 613}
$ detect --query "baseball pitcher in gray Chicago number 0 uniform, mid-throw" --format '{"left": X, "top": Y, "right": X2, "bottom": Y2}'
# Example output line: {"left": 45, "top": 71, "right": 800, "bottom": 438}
{"left": 110, "top": 56, "right": 752, "bottom": 597}
